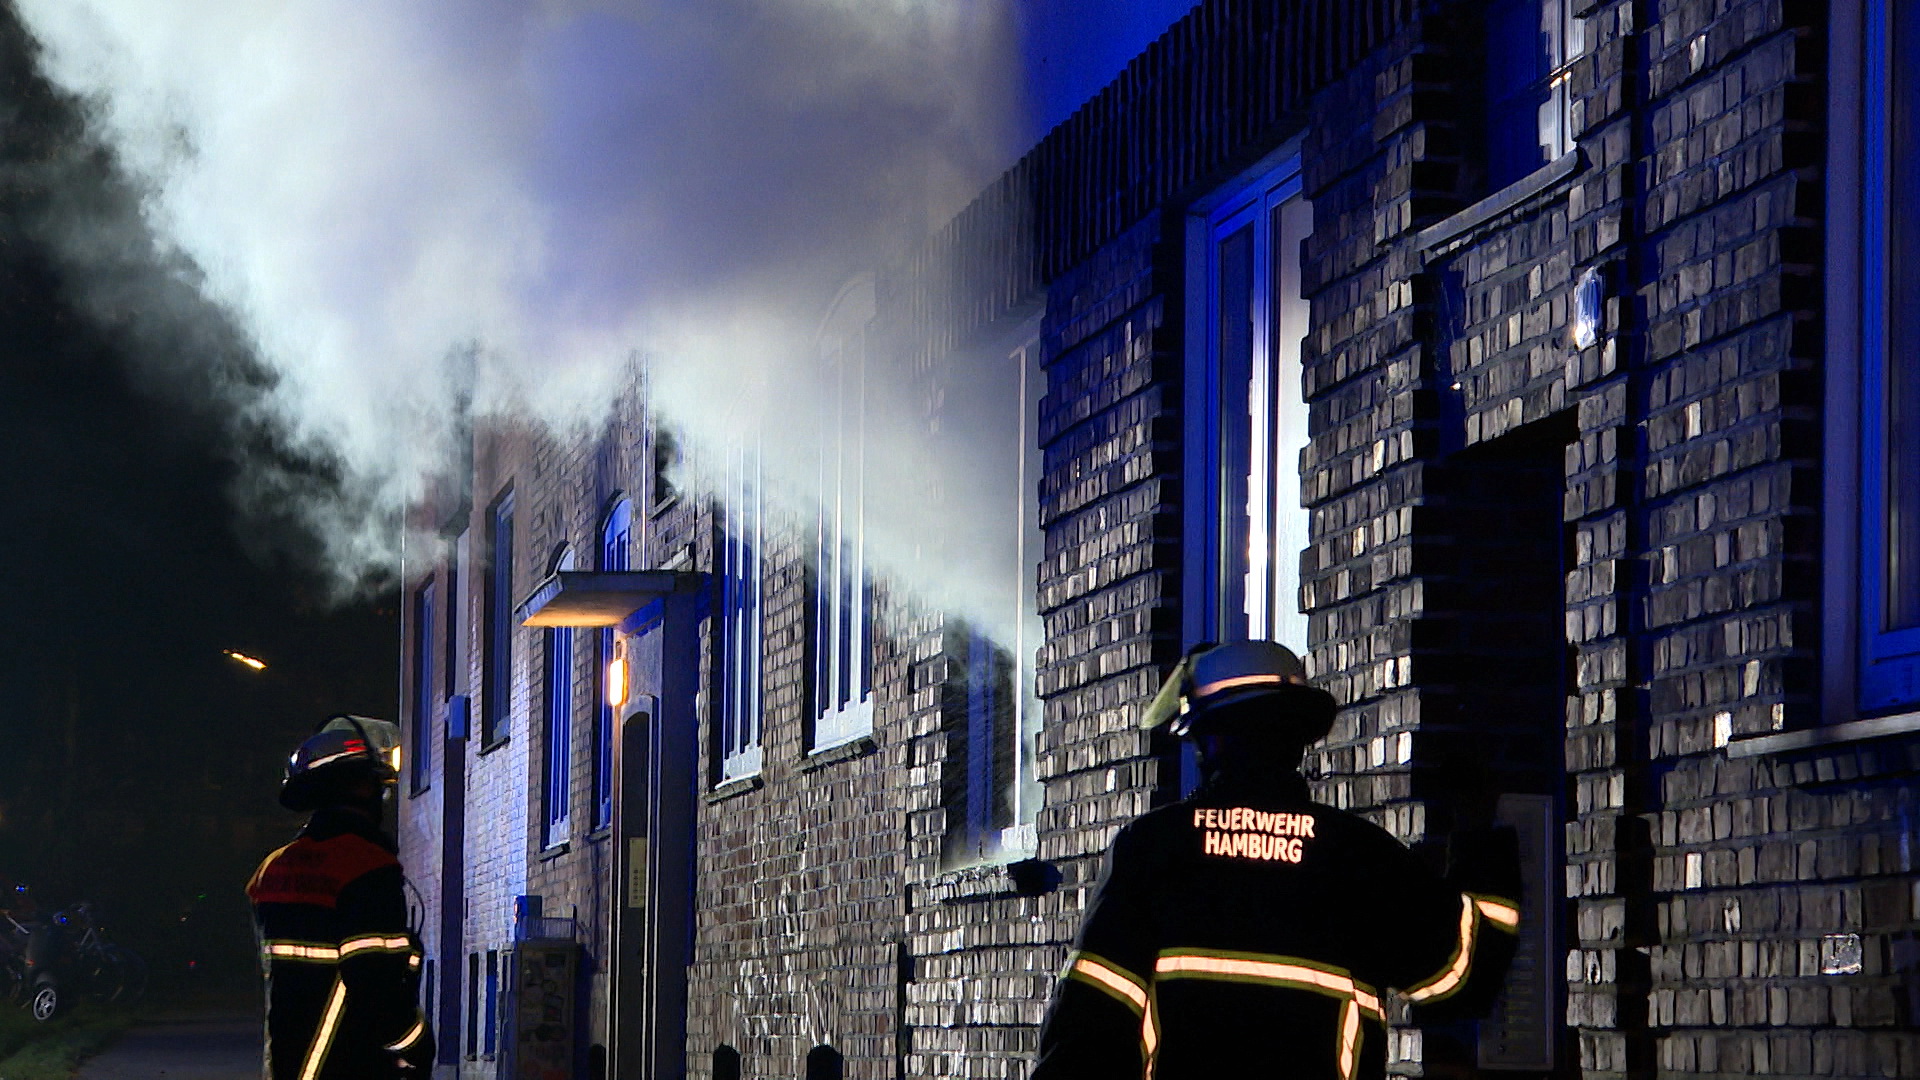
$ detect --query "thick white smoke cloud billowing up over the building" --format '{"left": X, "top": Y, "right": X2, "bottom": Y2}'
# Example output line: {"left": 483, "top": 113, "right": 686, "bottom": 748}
{"left": 17, "top": 0, "right": 1020, "bottom": 607}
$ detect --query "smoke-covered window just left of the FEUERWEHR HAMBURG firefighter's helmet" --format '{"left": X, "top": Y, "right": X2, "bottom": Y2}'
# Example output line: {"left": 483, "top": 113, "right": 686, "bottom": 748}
{"left": 941, "top": 325, "right": 1044, "bottom": 867}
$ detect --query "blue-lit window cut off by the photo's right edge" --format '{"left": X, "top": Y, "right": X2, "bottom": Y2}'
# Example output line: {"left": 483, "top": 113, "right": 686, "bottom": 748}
{"left": 1845, "top": 0, "right": 1920, "bottom": 715}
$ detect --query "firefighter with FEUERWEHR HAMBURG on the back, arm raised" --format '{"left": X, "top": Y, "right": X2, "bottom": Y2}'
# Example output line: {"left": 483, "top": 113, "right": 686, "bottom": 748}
{"left": 1031, "top": 642, "right": 1521, "bottom": 1080}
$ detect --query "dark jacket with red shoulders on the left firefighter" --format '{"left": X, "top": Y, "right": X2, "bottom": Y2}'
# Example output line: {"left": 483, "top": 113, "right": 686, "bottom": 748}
{"left": 248, "top": 809, "right": 434, "bottom": 1080}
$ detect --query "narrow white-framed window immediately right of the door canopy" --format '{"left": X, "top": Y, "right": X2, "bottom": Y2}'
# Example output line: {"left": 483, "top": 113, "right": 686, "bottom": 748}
{"left": 714, "top": 448, "right": 760, "bottom": 784}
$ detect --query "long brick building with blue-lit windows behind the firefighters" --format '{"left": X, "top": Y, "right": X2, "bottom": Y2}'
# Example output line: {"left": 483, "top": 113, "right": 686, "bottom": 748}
{"left": 403, "top": 0, "right": 1920, "bottom": 1078}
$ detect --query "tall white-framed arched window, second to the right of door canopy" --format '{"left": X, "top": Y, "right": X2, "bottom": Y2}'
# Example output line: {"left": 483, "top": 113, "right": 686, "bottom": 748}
{"left": 808, "top": 275, "right": 876, "bottom": 749}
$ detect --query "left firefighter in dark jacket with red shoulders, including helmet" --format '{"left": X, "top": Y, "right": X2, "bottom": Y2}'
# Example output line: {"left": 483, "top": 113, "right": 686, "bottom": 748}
{"left": 248, "top": 717, "right": 434, "bottom": 1080}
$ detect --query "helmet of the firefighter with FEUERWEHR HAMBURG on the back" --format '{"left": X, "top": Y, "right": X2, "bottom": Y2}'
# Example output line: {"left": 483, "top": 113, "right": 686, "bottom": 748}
{"left": 1140, "top": 642, "right": 1336, "bottom": 746}
